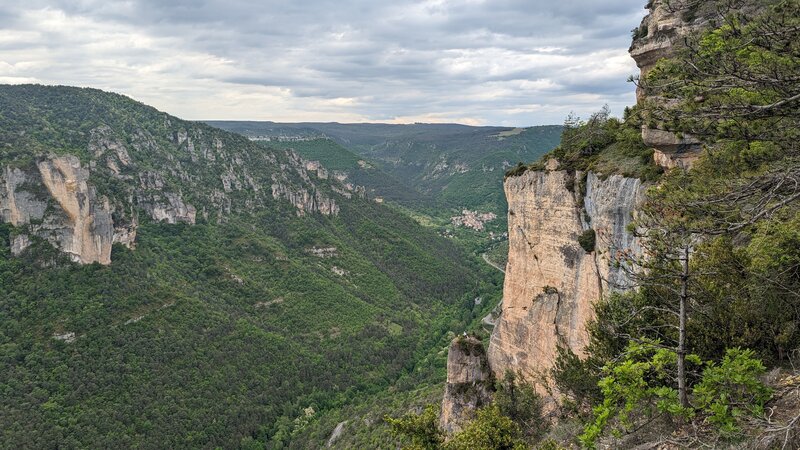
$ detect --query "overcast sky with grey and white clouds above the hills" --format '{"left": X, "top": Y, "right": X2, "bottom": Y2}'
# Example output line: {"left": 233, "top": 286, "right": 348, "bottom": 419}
{"left": 0, "top": 0, "right": 646, "bottom": 126}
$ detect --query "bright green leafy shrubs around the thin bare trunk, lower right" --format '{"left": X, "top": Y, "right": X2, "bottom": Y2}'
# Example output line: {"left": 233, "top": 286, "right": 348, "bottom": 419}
{"left": 580, "top": 339, "right": 772, "bottom": 448}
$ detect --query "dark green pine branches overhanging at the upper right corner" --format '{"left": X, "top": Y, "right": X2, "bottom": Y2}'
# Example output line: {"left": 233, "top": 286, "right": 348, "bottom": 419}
{"left": 640, "top": 0, "right": 800, "bottom": 227}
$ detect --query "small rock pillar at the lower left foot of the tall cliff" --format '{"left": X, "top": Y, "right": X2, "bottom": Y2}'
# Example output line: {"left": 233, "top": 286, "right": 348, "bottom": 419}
{"left": 439, "top": 336, "right": 494, "bottom": 434}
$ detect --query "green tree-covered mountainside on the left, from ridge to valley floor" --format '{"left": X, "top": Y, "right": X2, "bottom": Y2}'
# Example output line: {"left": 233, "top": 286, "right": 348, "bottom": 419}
{"left": 0, "top": 86, "right": 499, "bottom": 448}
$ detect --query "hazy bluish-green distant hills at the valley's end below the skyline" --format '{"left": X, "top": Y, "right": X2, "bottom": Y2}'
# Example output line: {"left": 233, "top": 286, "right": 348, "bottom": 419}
{"left": 208, "top": 121, "right": 561, "bottom": 214}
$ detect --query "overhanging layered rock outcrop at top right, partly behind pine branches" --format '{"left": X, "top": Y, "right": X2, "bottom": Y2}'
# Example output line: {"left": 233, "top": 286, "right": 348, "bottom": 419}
{"left": 628, "top": 0, "right": 708, "bottom": 169}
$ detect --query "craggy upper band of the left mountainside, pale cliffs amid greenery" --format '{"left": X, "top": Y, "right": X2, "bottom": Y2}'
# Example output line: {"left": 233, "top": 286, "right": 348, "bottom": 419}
{"left": 0, "top": 86, "right": 363, "bottom": 264}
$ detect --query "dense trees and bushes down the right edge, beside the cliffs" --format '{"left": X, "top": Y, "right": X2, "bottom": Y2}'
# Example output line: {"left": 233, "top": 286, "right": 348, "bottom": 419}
{"left": 554, "top": 1, "right": 800, "bottom": 447}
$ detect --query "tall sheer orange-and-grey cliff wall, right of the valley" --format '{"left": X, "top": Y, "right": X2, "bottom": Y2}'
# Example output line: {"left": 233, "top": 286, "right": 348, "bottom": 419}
{"left": 488, "top": 171, "right": 644, "bottom": 388}
